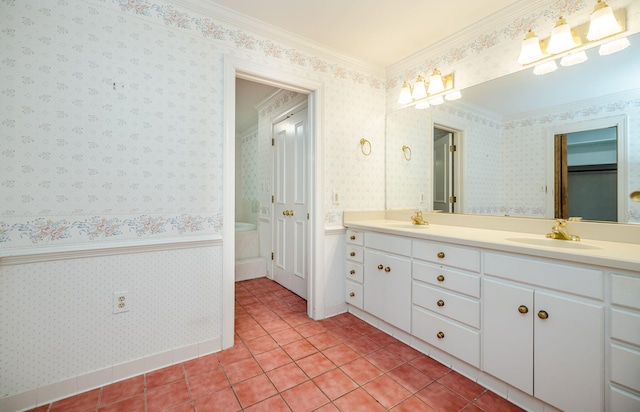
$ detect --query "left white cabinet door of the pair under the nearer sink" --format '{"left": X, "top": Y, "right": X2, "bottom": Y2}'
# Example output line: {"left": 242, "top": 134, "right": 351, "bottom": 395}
{"left": 482, "top": 278, "right": 534, "bottom": 395}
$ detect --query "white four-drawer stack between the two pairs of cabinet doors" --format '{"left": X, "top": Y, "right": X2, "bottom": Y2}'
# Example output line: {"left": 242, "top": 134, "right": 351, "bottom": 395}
{"left": 411, "top": 240, "right": 480, "bottom": 367}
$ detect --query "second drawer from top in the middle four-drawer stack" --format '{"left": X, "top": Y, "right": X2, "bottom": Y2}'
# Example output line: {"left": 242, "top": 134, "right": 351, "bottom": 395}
{"left": 413, "top": 261, "right": 480, "bottom": 298}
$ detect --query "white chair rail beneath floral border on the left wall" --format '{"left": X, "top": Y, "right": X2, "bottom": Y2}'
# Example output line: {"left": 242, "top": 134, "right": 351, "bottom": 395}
{"left": 0, "top": 235, "right": 222, "bottom": 267}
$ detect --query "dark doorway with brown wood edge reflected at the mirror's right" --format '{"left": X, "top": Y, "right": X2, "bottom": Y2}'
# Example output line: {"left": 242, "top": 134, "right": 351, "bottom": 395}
{"left": 554, "top": 126, "right": 618, "bottom": 222}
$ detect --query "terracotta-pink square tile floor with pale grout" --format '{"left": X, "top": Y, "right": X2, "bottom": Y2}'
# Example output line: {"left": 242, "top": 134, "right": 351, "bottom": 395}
{"left": 28, "top": 278, "right": 522, "bottom": 412}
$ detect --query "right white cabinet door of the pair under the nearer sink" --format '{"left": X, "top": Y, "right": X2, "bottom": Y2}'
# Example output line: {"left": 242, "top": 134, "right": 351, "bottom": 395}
{"left": 534, "top": 291, "right": 604, "bottom": 411}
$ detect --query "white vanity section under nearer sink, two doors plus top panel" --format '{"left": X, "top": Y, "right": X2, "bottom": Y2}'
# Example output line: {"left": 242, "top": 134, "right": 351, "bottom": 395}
{"left": 482, "top": 253, "right": 604, "bottom": 411}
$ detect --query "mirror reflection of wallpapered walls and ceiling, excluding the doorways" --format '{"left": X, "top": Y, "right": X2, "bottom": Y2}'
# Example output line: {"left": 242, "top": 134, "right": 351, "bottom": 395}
{"left": 387, "top": 34, "right": 640, "bottom": 223}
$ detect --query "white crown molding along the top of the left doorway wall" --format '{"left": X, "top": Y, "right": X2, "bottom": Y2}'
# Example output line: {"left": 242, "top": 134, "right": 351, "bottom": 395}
{"left": 165, "top": 0, "right": 385, "bottom": 80}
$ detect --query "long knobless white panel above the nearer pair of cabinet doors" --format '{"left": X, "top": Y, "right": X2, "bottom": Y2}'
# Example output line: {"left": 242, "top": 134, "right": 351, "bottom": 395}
{"left": 484, "top": 251, "right": 604, "bottom": 300}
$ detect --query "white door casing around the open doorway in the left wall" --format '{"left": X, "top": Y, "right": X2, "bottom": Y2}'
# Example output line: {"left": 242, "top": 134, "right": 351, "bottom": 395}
{"left": 222, "top": 54, "right": 324, "bottom": 349}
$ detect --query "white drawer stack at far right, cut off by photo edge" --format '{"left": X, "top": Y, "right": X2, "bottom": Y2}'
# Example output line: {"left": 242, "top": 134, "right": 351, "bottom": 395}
{"left": 609, "top": 272, "right": 640, "bottom": 412}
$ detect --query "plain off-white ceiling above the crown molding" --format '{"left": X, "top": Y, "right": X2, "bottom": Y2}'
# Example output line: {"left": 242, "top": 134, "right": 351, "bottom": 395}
{"left": 209, "top": 0, "right": 518, "bottom": 68}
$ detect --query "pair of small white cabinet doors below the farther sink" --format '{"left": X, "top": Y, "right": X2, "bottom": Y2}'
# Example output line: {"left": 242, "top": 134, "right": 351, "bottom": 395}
{"left": 364, "top": 249, "right": 411, "bottom": 332}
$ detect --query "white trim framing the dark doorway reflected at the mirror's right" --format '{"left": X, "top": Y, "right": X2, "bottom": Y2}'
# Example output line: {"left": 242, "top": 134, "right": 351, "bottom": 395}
{"left": 544, "top": 115, "right": 629, "bottom": 223}
